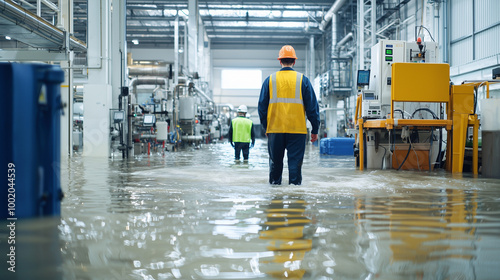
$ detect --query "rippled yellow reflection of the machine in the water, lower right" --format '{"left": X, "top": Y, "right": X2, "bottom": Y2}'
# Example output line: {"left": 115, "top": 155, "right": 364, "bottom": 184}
{"left": 356, "top": 189, "right": 478, "bottom": 279}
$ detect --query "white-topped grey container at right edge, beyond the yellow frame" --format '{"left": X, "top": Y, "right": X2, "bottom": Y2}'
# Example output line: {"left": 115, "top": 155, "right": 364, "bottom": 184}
{"left": 481, "top": 98, "right": 500, "bottom": 178}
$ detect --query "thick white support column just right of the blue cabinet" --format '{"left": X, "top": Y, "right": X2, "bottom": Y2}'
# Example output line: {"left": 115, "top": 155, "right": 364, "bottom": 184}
{"left": 83, "top": 0, "right": 112, "bottom": 157}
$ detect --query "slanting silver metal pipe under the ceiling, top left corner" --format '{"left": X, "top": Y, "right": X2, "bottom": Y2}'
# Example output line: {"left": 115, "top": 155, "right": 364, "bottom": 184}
{"left": 0, "top": 0, "right": 87, "bottom": 51}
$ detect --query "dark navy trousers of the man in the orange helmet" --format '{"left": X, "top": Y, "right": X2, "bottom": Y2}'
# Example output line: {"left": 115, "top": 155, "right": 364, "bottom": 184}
{"left": 267, "top": 133, "right": 307, "bottom": 185}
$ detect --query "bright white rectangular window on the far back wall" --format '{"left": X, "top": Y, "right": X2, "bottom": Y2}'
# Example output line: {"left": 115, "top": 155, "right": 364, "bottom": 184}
{"left": 221, "top": 69, "right": 262, "bottom": 89}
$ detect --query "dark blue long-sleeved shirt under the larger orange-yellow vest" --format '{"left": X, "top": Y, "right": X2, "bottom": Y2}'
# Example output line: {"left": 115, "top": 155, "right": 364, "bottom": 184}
{"left": 258, "top": 67, "right": 320, "bottom": 134}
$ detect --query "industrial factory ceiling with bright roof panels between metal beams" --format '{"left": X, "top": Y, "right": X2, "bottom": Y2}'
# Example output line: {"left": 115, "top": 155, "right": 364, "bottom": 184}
{"left": 0, "top": 0, "right": 352, "bottom": 48}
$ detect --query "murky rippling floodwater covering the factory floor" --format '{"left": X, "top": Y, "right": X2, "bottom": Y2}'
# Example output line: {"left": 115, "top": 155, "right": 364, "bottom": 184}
{"left": 0, "top": 140, "right": 500, "bottom": 280}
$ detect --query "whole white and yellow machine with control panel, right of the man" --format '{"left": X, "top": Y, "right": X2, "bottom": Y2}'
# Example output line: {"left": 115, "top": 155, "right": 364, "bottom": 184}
{"left": 355, "top": 41, "right": 498, "bottom": 174}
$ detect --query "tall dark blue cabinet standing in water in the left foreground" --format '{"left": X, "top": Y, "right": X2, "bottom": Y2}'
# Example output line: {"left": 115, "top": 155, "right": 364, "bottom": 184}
{"left": 0, "top": 63, "right": 64, "bottom": 218}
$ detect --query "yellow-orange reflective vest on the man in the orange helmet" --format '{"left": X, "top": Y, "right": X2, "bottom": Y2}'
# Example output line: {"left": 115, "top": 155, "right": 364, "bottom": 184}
{"left": 266, "top": 70, "right": 307, "bottom": 134}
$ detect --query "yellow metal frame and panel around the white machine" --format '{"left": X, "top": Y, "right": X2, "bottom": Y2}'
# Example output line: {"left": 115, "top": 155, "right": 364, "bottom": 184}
{"left": 354, "top": 63, "right": 490, "bottom": 174}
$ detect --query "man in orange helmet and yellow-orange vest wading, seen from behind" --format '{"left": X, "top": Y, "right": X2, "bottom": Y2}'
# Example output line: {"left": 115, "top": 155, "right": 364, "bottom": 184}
{"left": 258, "top": 45, "right": 320, "bottom": 185}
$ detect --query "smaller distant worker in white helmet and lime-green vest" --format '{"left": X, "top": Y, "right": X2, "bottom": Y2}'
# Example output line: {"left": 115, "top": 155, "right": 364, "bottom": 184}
{"left": 229, "top": 105, "right": 255, "bottom": 160}
